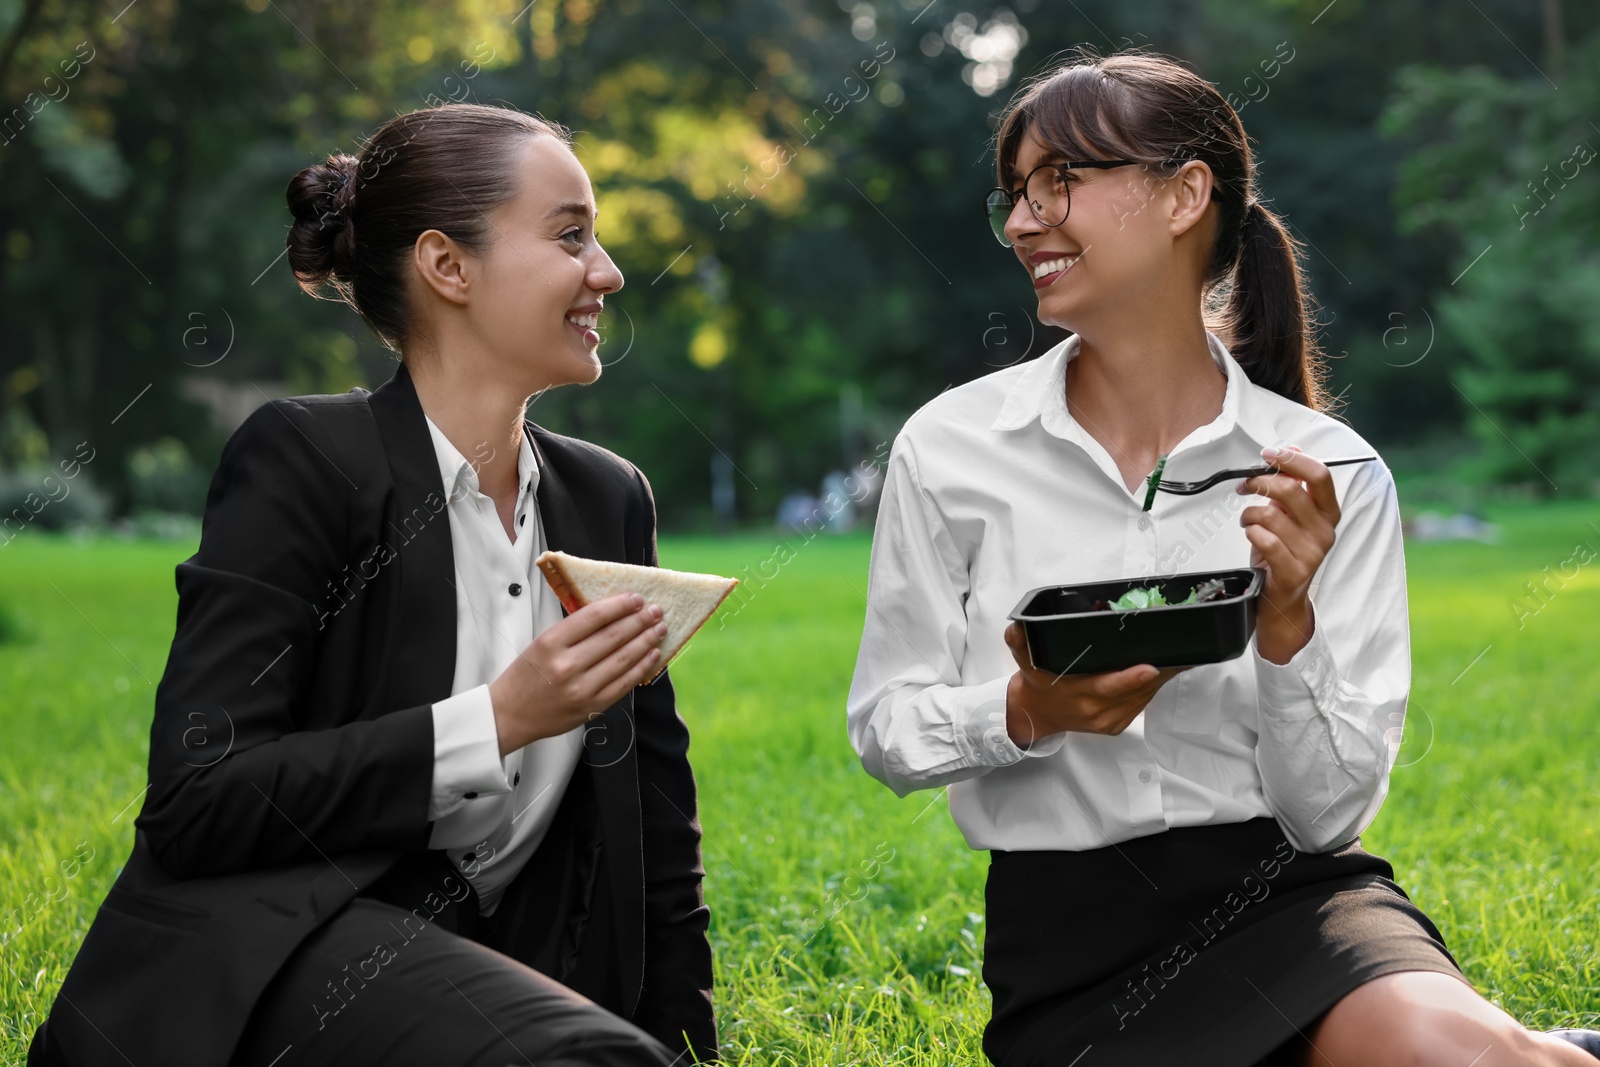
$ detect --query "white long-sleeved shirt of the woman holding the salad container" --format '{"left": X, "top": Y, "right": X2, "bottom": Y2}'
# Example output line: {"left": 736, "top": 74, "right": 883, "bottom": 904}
{"left": 848, "top": 329, "right": 1411, "bottom": 851}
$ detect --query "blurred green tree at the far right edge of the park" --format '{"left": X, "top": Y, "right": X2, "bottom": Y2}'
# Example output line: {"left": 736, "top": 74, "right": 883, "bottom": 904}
{"left": 1384, "top": 19, "right": 1600, "bottom": 494}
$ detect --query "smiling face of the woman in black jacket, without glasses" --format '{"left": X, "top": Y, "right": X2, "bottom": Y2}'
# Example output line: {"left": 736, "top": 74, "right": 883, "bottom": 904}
{"left": 466, "top": 136, "right": 622, "bottom": 394}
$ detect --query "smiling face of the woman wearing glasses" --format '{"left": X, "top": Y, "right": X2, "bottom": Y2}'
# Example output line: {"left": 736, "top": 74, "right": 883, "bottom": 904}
{"left": 1005, "top": 126, "right": 1214, "bottom": 340}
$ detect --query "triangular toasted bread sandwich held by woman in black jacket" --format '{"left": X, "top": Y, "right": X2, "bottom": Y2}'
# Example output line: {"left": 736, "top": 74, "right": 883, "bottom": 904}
{"left": 534, "top": 552, "right": 739, "bottom": 685}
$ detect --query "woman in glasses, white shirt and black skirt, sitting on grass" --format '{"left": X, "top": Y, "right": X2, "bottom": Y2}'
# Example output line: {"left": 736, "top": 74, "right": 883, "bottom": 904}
{"left": 848, "top": 53, "right": 1600, "bottom": 1067}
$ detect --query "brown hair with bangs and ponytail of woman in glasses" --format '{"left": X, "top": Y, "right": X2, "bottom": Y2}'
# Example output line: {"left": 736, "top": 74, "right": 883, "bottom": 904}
{"left": 995, "top": 48, "right": 1330, "bottom": 411}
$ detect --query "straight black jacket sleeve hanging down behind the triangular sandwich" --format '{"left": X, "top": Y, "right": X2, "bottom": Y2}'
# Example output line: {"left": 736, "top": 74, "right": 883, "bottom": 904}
{"left": 627, "top": 467, "right": 718, "bottom": 1062}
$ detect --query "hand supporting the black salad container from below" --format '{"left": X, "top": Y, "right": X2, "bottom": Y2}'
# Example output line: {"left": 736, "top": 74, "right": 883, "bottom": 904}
{"left": 1005, "top": 622, "right": 1189, "bottom": 749}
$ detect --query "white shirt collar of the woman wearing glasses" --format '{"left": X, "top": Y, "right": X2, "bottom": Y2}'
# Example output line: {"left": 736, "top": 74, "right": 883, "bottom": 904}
{"left": 989, "top": 331, "right": 1282, "bottom": 451}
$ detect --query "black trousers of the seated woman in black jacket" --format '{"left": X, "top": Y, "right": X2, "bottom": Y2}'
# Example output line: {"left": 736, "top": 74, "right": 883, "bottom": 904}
{"left": 232, "top": 809, "right": 672, "bottom": 1067}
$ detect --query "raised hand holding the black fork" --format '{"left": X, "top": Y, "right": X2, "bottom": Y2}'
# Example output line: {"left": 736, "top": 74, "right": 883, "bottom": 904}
{"left": 1238, "top": 445, "right": 1339, "bottom": 664}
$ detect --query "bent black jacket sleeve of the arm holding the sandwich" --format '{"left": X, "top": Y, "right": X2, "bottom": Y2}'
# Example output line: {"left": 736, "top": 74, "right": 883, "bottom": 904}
{"left": 138, "top": 400, "right": 434, "bottom": 878}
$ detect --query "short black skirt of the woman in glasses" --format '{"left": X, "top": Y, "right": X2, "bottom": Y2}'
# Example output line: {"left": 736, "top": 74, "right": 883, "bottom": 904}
{"left": 984, "top": 817, "right": 1466, "bottom": 1067}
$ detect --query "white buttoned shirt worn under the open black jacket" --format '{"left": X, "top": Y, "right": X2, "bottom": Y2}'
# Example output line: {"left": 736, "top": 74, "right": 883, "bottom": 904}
{"left": 424, "top": 416, "right": 584, "bottom": 915}
